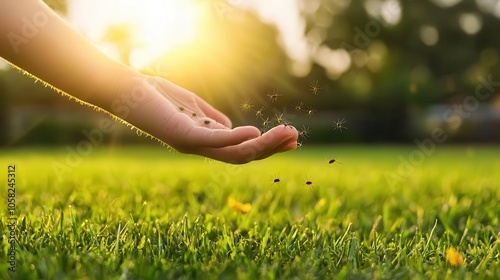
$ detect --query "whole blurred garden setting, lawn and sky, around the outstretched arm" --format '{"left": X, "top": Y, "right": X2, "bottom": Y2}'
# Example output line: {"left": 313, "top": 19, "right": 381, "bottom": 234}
{"left": 0, "top": 0, "right": 500, "bottom": 279}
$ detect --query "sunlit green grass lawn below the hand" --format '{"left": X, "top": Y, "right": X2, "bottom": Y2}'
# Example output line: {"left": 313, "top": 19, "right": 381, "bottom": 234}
{"left": 0, "top": 146, "right": 500, "bottom": 279}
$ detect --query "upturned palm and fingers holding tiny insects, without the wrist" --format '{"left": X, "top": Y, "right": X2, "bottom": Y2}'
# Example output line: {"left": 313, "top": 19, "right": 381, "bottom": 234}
{"left": 153, "top": 77, "right": 298, "bottom": 163}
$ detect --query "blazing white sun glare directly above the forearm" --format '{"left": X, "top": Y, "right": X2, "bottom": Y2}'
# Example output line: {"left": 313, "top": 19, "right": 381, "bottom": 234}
{"left": 68, "top": 0, "right": 204, "bottom": 69}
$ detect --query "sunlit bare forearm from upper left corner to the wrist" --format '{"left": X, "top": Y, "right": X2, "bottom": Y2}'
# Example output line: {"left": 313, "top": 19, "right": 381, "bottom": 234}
{"left": 0, "top": 0, "right": 139, "bottom": 112}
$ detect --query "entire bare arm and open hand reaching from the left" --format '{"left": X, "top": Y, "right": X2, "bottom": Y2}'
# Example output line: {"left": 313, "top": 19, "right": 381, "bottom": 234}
{"left": 0, "top": 0, "right": 298, "bottom": 164}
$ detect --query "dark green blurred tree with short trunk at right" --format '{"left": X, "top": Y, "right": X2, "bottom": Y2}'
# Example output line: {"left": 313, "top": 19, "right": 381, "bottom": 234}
{"left": 298, "top": 0, "right": 500, "bottom": 141}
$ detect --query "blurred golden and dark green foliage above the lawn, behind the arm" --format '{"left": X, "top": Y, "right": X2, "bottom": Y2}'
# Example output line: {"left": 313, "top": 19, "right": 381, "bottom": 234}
{"left": 0, "top": 0, "right": 500, "bottom": 145}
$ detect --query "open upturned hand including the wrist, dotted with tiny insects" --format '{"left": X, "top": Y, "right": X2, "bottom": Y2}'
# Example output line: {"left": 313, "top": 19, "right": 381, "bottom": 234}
{"left": 117, "top": 76, "right": 298, "bottom": 164}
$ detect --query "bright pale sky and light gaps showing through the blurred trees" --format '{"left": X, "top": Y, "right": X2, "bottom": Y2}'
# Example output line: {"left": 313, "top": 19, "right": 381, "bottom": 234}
{"left": 0, "top": 0, "right": 500, "bottom": 75}
